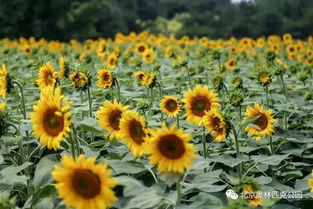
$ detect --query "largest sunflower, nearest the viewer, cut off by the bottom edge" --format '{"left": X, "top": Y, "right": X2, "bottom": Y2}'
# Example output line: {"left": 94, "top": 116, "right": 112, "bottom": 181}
{"left": 51, "top": 155, "right": 117, "bottom": 209}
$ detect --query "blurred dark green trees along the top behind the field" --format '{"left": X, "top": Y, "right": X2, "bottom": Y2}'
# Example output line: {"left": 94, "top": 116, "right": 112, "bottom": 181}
{"left": 0, "top": 0, "right": 313, "bottom": 41}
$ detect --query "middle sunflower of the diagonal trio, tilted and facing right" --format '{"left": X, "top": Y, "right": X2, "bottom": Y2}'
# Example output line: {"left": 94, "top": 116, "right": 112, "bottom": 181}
{"left": 118, "top": 110, "right": 147, "bottom": 157}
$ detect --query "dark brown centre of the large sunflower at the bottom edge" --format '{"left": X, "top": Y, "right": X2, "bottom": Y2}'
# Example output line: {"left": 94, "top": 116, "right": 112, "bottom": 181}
{"left": 72, "top": 169, "right": 101, "bottom": 199}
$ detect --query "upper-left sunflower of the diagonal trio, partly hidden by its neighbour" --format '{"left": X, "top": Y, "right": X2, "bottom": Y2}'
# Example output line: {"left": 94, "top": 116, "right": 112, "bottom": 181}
{"left": 96, "top": 99, "right": 128, "bottom": 138}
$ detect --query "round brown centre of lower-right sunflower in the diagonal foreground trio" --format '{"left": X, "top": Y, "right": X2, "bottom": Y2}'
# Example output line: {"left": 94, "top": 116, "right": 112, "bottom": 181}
{"left": 158, "top": 134, "right": 186, "bottom": 159}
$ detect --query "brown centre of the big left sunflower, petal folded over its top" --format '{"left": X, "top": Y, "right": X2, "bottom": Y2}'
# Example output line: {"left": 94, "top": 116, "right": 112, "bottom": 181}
{"left": 43, "top": 110, "right": 64, "bottom": 136}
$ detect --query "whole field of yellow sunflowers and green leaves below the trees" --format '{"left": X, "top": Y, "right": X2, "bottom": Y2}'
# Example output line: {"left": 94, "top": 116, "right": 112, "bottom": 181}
{"left": 0, "top": 32, "right": 313, "bottom": 209}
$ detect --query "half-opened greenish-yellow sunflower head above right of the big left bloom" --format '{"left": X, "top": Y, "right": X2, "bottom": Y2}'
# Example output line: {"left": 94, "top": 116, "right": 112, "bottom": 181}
{"left": 69, "top": 70, "right": 91, "bottom": 91}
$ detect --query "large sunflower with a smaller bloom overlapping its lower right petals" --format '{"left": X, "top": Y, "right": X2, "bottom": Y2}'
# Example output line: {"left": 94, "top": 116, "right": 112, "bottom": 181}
{"left": 182, "top": 84, "right": 220, "bottom": 125}
